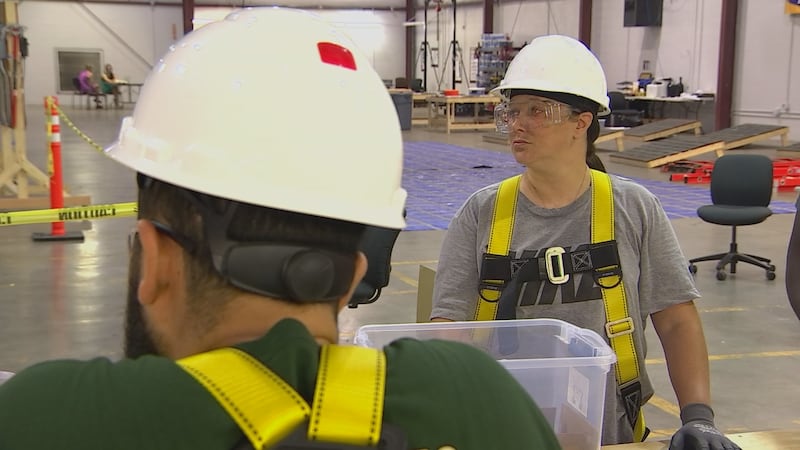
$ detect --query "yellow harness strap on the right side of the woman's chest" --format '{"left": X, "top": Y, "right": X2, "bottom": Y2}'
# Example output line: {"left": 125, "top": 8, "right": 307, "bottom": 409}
{"left": 591, "top": 170, "right": 647, "bottom": 442}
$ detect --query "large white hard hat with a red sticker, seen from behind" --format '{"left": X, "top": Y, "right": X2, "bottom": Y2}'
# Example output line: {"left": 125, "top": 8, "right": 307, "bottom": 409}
{"left": 106, "top": 7, "right": 406, "bottom": 228}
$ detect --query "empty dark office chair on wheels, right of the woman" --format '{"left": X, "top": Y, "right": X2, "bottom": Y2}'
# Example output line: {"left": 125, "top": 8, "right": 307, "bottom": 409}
{"left": 689, "top": 154, "right": 775, "bottom": 281}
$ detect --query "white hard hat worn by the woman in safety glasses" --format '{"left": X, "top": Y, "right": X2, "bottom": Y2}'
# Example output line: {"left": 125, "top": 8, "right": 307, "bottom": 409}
{"left": 492, "top": 35, "right": 609, "bottom": 115}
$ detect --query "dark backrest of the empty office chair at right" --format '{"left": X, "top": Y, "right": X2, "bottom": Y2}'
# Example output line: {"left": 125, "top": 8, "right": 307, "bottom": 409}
{"left": 711, "top": 154, "right": 773, "bottom": 206}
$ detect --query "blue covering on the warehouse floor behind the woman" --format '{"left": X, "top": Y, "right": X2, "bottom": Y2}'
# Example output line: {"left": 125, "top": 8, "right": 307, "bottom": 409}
{"left": 403, "top": 142, "right": 795, "bottom": 231}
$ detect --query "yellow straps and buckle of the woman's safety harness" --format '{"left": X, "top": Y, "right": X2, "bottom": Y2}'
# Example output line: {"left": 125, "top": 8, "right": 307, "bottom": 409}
{"left": 475, "top": 170, "right": 649, "bottom": 442}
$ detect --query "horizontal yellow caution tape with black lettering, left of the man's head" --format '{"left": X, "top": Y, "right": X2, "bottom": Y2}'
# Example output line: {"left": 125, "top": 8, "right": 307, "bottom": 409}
{"left": 0, "top": 202, "right": 139, "bottom": 226}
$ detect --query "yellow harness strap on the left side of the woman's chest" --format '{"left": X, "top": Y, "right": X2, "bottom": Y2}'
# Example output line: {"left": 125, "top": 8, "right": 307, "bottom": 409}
{"left": 475, "top": 175, "right": 522, "bottom": 320}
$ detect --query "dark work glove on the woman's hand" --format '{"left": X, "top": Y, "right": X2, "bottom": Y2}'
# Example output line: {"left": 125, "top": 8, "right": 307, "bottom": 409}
{"left": 669, "top": 403, "right": 742, "bottom": 450}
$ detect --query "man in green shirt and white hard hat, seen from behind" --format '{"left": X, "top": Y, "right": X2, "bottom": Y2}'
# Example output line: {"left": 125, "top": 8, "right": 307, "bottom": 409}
{"left": 0, "top": 8, "right": 559, "bottom": 450}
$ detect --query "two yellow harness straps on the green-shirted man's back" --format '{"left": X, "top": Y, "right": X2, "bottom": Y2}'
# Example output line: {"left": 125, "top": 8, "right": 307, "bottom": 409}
{"left": 177, "top": 345, "right": 386, "bottom": 450}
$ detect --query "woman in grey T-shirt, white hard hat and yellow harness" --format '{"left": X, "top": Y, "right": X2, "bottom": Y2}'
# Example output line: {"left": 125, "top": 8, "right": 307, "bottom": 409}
{"left": 431, "top": 36, "right": 739, "bottom": 450}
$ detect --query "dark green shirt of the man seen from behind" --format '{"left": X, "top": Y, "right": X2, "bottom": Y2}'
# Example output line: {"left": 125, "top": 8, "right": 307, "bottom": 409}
{"left": 0, "top": 320, "right": 560, "bottom": 450}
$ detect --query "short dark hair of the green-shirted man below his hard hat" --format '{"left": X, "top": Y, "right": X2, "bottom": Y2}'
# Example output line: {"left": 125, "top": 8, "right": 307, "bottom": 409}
{"left": 138, "top": 174, "right": 365, "bottom": 327}
